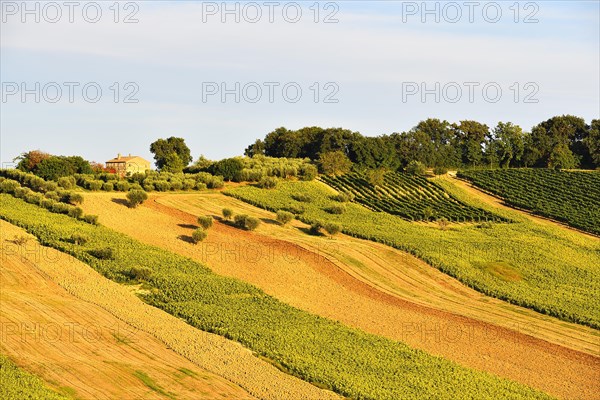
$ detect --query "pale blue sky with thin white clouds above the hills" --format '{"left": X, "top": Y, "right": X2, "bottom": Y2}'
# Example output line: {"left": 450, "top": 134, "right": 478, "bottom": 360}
{"left": 0, "top": 0, "right": 600, "bottom": 167}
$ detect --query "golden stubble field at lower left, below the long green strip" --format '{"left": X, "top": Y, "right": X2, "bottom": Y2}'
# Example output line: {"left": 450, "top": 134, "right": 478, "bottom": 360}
{"left": 0, "top": 221, "right": 339, "bottom": 399}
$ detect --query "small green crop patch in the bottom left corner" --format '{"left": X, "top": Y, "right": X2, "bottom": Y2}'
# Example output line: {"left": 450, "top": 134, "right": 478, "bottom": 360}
{"left": 0, "top": 354, "right": 67, "bottom": 400}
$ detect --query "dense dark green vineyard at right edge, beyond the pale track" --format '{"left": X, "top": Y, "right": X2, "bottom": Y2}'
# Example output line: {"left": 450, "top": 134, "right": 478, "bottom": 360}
{"left": 458, "top": 169, "right": 600, "bottom": 235}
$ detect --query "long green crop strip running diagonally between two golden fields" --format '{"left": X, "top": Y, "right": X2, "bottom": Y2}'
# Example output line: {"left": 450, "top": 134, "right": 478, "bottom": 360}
{"left": 1, "top": 194, "right": 545, "bottom": 399}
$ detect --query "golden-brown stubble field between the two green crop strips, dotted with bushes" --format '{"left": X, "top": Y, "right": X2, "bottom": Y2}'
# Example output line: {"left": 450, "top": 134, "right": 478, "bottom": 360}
{"left": 83, "top": 192, "right": 600, "bottom": 398}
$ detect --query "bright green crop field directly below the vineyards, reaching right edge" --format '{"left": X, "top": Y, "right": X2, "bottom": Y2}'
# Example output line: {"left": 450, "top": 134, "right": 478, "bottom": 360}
{"left": 226, "top": 182, "right": 600, "bottom": 328}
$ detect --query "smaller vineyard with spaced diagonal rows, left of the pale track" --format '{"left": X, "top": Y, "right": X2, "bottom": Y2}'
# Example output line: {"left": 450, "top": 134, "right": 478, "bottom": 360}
{"left": 322, "top": 173, "right": 506, "bottom": 222}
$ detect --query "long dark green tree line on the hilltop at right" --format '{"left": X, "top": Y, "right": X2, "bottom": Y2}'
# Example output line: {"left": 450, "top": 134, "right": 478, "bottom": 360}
{"left": 244, "top": 115, "right": 600, "bottom": 170}
